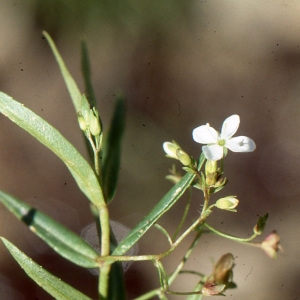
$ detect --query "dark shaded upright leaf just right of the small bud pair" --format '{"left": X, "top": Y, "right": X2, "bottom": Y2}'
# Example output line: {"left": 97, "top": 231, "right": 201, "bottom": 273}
{"left": 102, "top": 96, "right": 125, "bottom": 203}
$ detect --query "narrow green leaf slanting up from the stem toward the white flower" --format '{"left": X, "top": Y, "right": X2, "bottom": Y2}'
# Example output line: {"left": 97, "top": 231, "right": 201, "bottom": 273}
{"left": 113, "top": 173, "right": 196, "bottom": 255}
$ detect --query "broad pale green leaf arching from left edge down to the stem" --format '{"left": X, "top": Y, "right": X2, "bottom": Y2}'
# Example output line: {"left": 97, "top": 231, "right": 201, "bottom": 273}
{"left": 0, "top": 92, "right": 104, "bottom": 207}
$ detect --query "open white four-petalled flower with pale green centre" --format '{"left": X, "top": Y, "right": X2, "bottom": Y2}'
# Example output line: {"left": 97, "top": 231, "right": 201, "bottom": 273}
{"left": 193, "top": 115, "right": 256, "bottom": 160}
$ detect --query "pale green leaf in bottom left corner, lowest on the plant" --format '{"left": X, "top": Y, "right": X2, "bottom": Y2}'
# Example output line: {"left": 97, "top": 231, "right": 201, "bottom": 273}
{"left": 1, "top": 237, "right": 91, "bottom": 300}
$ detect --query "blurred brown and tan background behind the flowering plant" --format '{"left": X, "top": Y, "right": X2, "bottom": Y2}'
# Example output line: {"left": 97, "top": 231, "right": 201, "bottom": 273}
{"left": 0, "top": 0, "right": 300, "bottom": 300}
